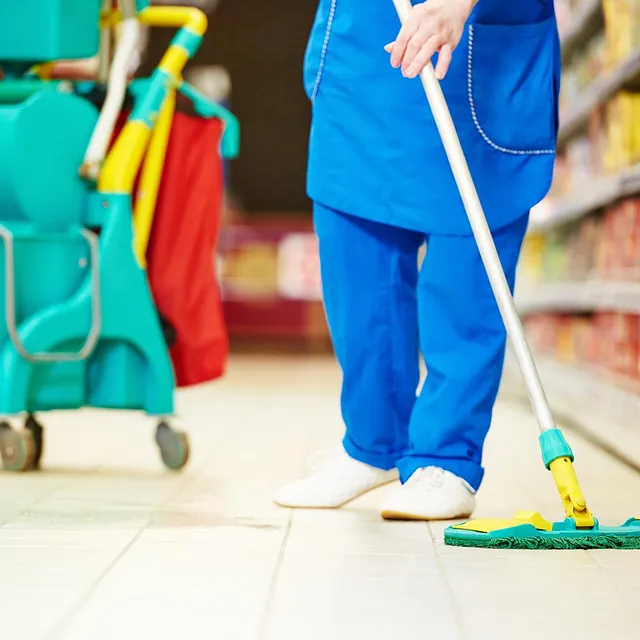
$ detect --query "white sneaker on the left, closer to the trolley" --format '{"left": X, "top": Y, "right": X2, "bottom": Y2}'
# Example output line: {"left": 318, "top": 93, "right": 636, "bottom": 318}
{"left": 273, "top": 448, "right": 398, "bottom": 509}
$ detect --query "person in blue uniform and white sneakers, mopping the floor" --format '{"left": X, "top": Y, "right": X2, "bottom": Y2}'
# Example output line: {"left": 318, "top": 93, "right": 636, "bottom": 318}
{"left": 274, "top": 0, "right": 560, "bottom": 520}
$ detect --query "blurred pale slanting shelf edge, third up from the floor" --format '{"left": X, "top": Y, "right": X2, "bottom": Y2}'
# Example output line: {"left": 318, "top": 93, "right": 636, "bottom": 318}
{"left": 529, "top": 165, "right": 640, "bottom": 232}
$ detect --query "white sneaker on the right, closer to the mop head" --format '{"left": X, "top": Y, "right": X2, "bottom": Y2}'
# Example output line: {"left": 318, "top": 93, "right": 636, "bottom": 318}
{"left": 380, "top": 467, "right": 475, "bottom": 520}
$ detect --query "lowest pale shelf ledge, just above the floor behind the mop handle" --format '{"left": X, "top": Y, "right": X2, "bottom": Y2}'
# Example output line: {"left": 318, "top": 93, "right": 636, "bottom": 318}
{"left": 501, "top": 352, "right": 640, "bottom": 468}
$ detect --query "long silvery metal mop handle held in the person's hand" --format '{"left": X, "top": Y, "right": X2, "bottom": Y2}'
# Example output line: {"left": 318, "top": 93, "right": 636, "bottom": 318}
{"left": 393, "top": 0, "right": 556, "bottom": 431}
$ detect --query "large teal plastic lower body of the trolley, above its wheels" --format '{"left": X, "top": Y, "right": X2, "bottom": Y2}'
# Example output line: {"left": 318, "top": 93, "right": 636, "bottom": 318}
{"left": 0, "top": 88, "right": 175, "bottom": 415}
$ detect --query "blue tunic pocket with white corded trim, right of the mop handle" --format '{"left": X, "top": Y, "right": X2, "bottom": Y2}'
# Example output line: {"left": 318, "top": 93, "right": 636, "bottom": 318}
{"left": 467, "top": 18, "right": 559, "bottom": 155}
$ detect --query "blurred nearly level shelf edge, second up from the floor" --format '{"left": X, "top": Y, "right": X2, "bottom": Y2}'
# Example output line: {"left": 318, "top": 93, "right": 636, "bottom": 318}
{"left": 517, "top": 281, "right": 640, "bottom": 315}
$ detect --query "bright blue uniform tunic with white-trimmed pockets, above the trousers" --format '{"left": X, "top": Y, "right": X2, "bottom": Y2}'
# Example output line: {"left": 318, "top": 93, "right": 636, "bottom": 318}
{"left": 304, "top": 0, "right": 560, "bottom": 235}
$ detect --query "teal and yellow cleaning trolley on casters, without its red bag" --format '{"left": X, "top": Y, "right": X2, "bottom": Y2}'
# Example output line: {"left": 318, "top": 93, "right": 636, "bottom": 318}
{"left": 0, "top": 0, "right": 238, "bottom": 470}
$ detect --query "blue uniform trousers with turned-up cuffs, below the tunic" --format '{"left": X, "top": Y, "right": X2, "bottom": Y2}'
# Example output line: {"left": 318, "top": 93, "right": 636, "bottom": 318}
{"left": 314, "top": 203, "right": 528, "bottom": 489}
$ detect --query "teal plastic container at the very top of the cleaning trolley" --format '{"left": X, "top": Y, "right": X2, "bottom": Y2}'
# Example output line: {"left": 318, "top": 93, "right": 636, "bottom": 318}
{"left": 0, "top": 0, "right": 102, "bottom": 64}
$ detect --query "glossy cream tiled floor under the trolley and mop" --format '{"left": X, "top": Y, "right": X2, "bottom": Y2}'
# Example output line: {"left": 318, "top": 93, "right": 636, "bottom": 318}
{"left": 0, "top": 358, "right": 640, "bottom": 640}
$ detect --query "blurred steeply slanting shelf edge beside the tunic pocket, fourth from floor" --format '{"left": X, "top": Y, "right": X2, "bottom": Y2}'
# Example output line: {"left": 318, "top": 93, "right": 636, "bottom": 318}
{"left": 558, "top": 50, "right": 640, "bottom": 148}
